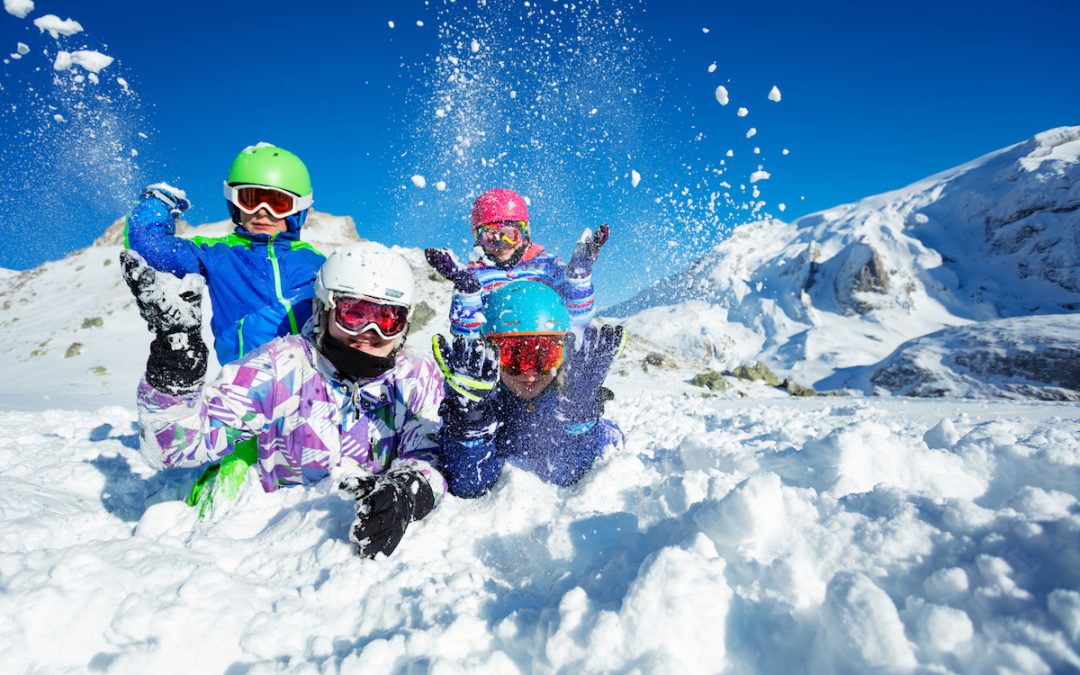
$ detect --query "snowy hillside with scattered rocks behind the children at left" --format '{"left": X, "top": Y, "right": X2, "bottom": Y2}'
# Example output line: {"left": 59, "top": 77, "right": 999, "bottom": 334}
{"left": 0, "top": 212, "right": 450, "bottom": 409}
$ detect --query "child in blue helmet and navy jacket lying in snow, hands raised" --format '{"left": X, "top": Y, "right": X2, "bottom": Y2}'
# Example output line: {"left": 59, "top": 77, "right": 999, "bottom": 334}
{"left": 433, "top": 281, "right": 623, "bottom": 497}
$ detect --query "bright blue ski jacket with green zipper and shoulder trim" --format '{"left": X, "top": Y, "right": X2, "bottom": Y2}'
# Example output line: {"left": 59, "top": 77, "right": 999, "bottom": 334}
{"left": 124, "top": 197, "right": 326, "bottom": 365}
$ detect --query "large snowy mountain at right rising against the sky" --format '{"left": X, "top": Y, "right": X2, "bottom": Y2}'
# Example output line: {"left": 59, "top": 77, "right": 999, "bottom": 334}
{"left": 608, "top": 126, "right": 1080, "bottom": 382}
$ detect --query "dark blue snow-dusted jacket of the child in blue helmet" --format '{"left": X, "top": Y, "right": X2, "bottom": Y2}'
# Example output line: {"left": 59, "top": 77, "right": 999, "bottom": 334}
{"left": 440, "top": 383, "right": 623, "bottom": 497}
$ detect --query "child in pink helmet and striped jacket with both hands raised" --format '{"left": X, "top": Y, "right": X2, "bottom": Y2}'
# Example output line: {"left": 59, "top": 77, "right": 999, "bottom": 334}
{"left": 426, "top": 188, "right": 609, "bottom": 339}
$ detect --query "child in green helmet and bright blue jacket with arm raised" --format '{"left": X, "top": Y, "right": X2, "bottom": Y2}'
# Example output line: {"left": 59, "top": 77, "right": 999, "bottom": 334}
{"left": 124, "top": 143, "right": 325, "bottom": 513}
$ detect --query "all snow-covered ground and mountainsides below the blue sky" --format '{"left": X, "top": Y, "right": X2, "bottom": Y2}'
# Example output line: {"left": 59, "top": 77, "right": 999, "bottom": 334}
{"left": 0, "top": 127, "right": 1080, "bottom": 674}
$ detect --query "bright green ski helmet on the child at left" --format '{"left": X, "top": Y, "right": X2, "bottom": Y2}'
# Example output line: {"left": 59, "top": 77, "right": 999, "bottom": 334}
{"left": 225, "top": 141, "right": 314, "bottom": 229}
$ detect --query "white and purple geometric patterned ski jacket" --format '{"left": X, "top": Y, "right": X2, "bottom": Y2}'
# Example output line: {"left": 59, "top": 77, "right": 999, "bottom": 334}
{"left": 138, "top": 329, "right": 446, "bottom": 496}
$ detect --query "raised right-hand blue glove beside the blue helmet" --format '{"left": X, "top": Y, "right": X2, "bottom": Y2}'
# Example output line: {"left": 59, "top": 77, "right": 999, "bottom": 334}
{"left": 555, "top": 326, "right": 626, "bottom": 422}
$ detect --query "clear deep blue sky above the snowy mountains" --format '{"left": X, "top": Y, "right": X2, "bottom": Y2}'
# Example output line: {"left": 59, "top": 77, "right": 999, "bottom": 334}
{"left": 0, "top": 0, "right": 1080, "bottom": 305}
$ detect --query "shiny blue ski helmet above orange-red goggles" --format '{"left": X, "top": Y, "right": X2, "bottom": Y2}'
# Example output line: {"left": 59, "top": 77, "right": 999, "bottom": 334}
{"left": 484, "top": 281, "right": 570, "bottom": 337}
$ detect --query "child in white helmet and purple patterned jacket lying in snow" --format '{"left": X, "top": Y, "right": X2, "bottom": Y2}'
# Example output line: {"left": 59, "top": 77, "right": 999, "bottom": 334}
{"left": 121, "top": 244, "right": 446, "bottom": 557}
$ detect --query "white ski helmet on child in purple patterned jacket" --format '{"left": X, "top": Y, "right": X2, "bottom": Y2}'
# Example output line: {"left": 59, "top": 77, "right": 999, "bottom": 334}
{"left": 315, "top": 242, "right": 415, "bottom": 311}
